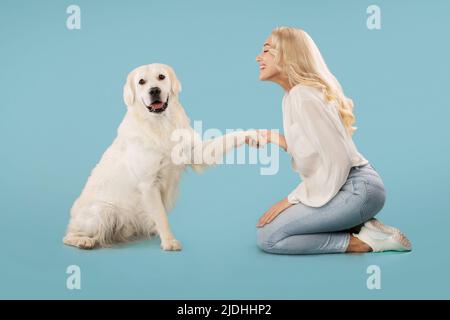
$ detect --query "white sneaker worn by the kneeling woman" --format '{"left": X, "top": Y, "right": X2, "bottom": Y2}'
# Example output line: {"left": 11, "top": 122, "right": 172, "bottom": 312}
{"left": 353, "top": 219, "right": 412, "bottom": 252}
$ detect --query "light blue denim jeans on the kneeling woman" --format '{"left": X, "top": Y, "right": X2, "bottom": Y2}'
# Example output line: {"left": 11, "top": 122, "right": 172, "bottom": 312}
{"left": 257, "top": 163, "right": 386, "bottom": 254}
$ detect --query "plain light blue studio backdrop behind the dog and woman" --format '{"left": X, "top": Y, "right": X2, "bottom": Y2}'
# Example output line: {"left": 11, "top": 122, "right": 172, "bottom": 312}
{"left": 0, "top": 0, "right": 450, "bottom": 299}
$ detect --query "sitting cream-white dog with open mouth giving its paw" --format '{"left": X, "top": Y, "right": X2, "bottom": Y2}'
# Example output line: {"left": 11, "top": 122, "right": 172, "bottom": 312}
{"left": 63, "top": 64, "right": 257, "bottom": 250}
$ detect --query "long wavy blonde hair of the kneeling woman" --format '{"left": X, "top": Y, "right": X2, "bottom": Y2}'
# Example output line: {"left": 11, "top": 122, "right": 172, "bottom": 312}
{"left": 269, "top": 27, "right": 356, "bottom": 136}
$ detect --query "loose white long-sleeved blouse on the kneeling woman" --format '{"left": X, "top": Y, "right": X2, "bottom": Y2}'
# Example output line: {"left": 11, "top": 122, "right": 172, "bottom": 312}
{"left": 282, "top": 85, "right": 369, "bottom": 207}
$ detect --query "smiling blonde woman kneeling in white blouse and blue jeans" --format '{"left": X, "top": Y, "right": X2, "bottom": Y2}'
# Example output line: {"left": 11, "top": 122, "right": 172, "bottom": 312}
{"left": 251, "top": 27, "right": 411, "bottom": 254}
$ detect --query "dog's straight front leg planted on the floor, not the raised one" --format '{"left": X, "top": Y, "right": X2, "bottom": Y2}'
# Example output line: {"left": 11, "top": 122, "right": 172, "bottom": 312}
{"left": 139, "top": 184, "right": 181, "bottom": 251}
